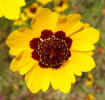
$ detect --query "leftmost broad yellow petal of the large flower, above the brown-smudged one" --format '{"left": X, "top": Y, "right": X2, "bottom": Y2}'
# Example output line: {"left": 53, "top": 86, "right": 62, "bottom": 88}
{"left": 6, "top": 28, "right": 38, "bottom": 55}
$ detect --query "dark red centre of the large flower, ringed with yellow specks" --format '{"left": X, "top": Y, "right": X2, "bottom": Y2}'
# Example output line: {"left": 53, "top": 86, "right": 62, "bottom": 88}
{"left": 30, "top": 30, "right": 72, "bottom": 69}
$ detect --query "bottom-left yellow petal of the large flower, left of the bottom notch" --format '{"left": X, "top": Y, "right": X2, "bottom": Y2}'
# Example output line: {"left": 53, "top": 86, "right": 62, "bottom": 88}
{"left": 25, "top": 63, "right": 51, "bottom": 93}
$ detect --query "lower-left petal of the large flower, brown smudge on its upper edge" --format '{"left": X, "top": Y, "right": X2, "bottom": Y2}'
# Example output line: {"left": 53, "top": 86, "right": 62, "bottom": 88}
{"left": 10, "top": 50, "right": 36, "bottom": 75}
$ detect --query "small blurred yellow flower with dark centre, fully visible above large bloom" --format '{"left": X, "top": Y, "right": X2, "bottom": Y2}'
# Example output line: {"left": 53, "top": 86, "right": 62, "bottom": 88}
{"left": 24, "top": 3, "right": 41, "bottom": 18}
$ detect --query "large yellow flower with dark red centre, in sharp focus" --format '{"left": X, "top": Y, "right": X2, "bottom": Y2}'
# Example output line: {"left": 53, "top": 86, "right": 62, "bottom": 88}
{"left": 6, "top": 8, "right": 99, "bottom": 93}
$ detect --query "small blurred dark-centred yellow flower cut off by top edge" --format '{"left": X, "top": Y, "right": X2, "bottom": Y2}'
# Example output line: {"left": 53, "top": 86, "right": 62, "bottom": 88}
{"left": 53, "top": 0, "right": 69, "bottom": 12}
